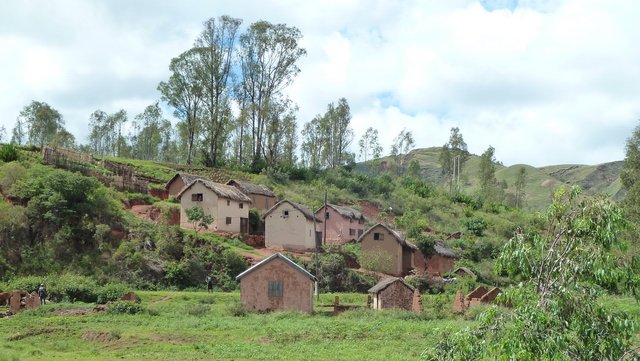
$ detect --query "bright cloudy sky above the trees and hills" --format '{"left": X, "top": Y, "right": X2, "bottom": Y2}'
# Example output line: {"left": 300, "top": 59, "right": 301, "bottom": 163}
{"left": 0, "top": 0, "right": 640, "bottom": 166}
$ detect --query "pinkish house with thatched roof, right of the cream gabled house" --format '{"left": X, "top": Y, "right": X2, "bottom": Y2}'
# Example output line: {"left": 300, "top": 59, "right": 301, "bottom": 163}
{"left": 316, "top": 204, "right": 366, "bottom": 244}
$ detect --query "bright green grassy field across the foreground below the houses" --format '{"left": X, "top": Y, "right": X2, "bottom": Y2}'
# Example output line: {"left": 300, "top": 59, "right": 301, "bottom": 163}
{"left": 0, "top": 292, "right": 472, "bottom": 361}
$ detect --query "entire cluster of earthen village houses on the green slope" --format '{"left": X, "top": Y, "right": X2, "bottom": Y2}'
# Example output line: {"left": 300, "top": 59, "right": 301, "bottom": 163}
{"left": 166, "top": 173, "right": 476, "bottom": 312}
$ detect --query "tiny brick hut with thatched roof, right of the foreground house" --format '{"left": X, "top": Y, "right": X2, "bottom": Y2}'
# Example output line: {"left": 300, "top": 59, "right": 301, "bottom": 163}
{"left": 369, "top": 278, "right": 415, "bottom": 311}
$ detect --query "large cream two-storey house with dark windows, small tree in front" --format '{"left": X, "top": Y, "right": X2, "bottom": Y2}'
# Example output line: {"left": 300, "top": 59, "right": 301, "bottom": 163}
{"left": 177, "top": 178, "right": 251, "bottom": 233}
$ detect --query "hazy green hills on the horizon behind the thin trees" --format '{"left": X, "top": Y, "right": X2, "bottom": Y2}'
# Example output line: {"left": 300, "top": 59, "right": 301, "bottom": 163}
{"left": 372, "top": 147, "right": 625, "bottom": 210}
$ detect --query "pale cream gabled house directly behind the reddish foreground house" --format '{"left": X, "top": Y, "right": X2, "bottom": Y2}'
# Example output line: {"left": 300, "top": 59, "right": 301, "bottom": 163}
{"left": 263, "top": 199, "right": 322, "bottom": 251}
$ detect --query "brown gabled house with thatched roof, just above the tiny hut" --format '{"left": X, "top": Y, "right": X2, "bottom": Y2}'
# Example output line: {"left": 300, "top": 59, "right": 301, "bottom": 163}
{"left": 358, "top": 223, "right": 418, "bottom": 276}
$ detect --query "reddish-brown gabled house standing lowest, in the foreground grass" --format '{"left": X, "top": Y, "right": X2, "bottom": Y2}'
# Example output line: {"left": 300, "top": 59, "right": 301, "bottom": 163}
{"left": 236, "top": 253, "right": 316, "bottom": 314}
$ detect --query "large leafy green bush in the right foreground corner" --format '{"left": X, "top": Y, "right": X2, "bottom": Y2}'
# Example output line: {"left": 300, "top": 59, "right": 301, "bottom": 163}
{"left": 426, "top": 188, "right": 640, "bottom": 360}
